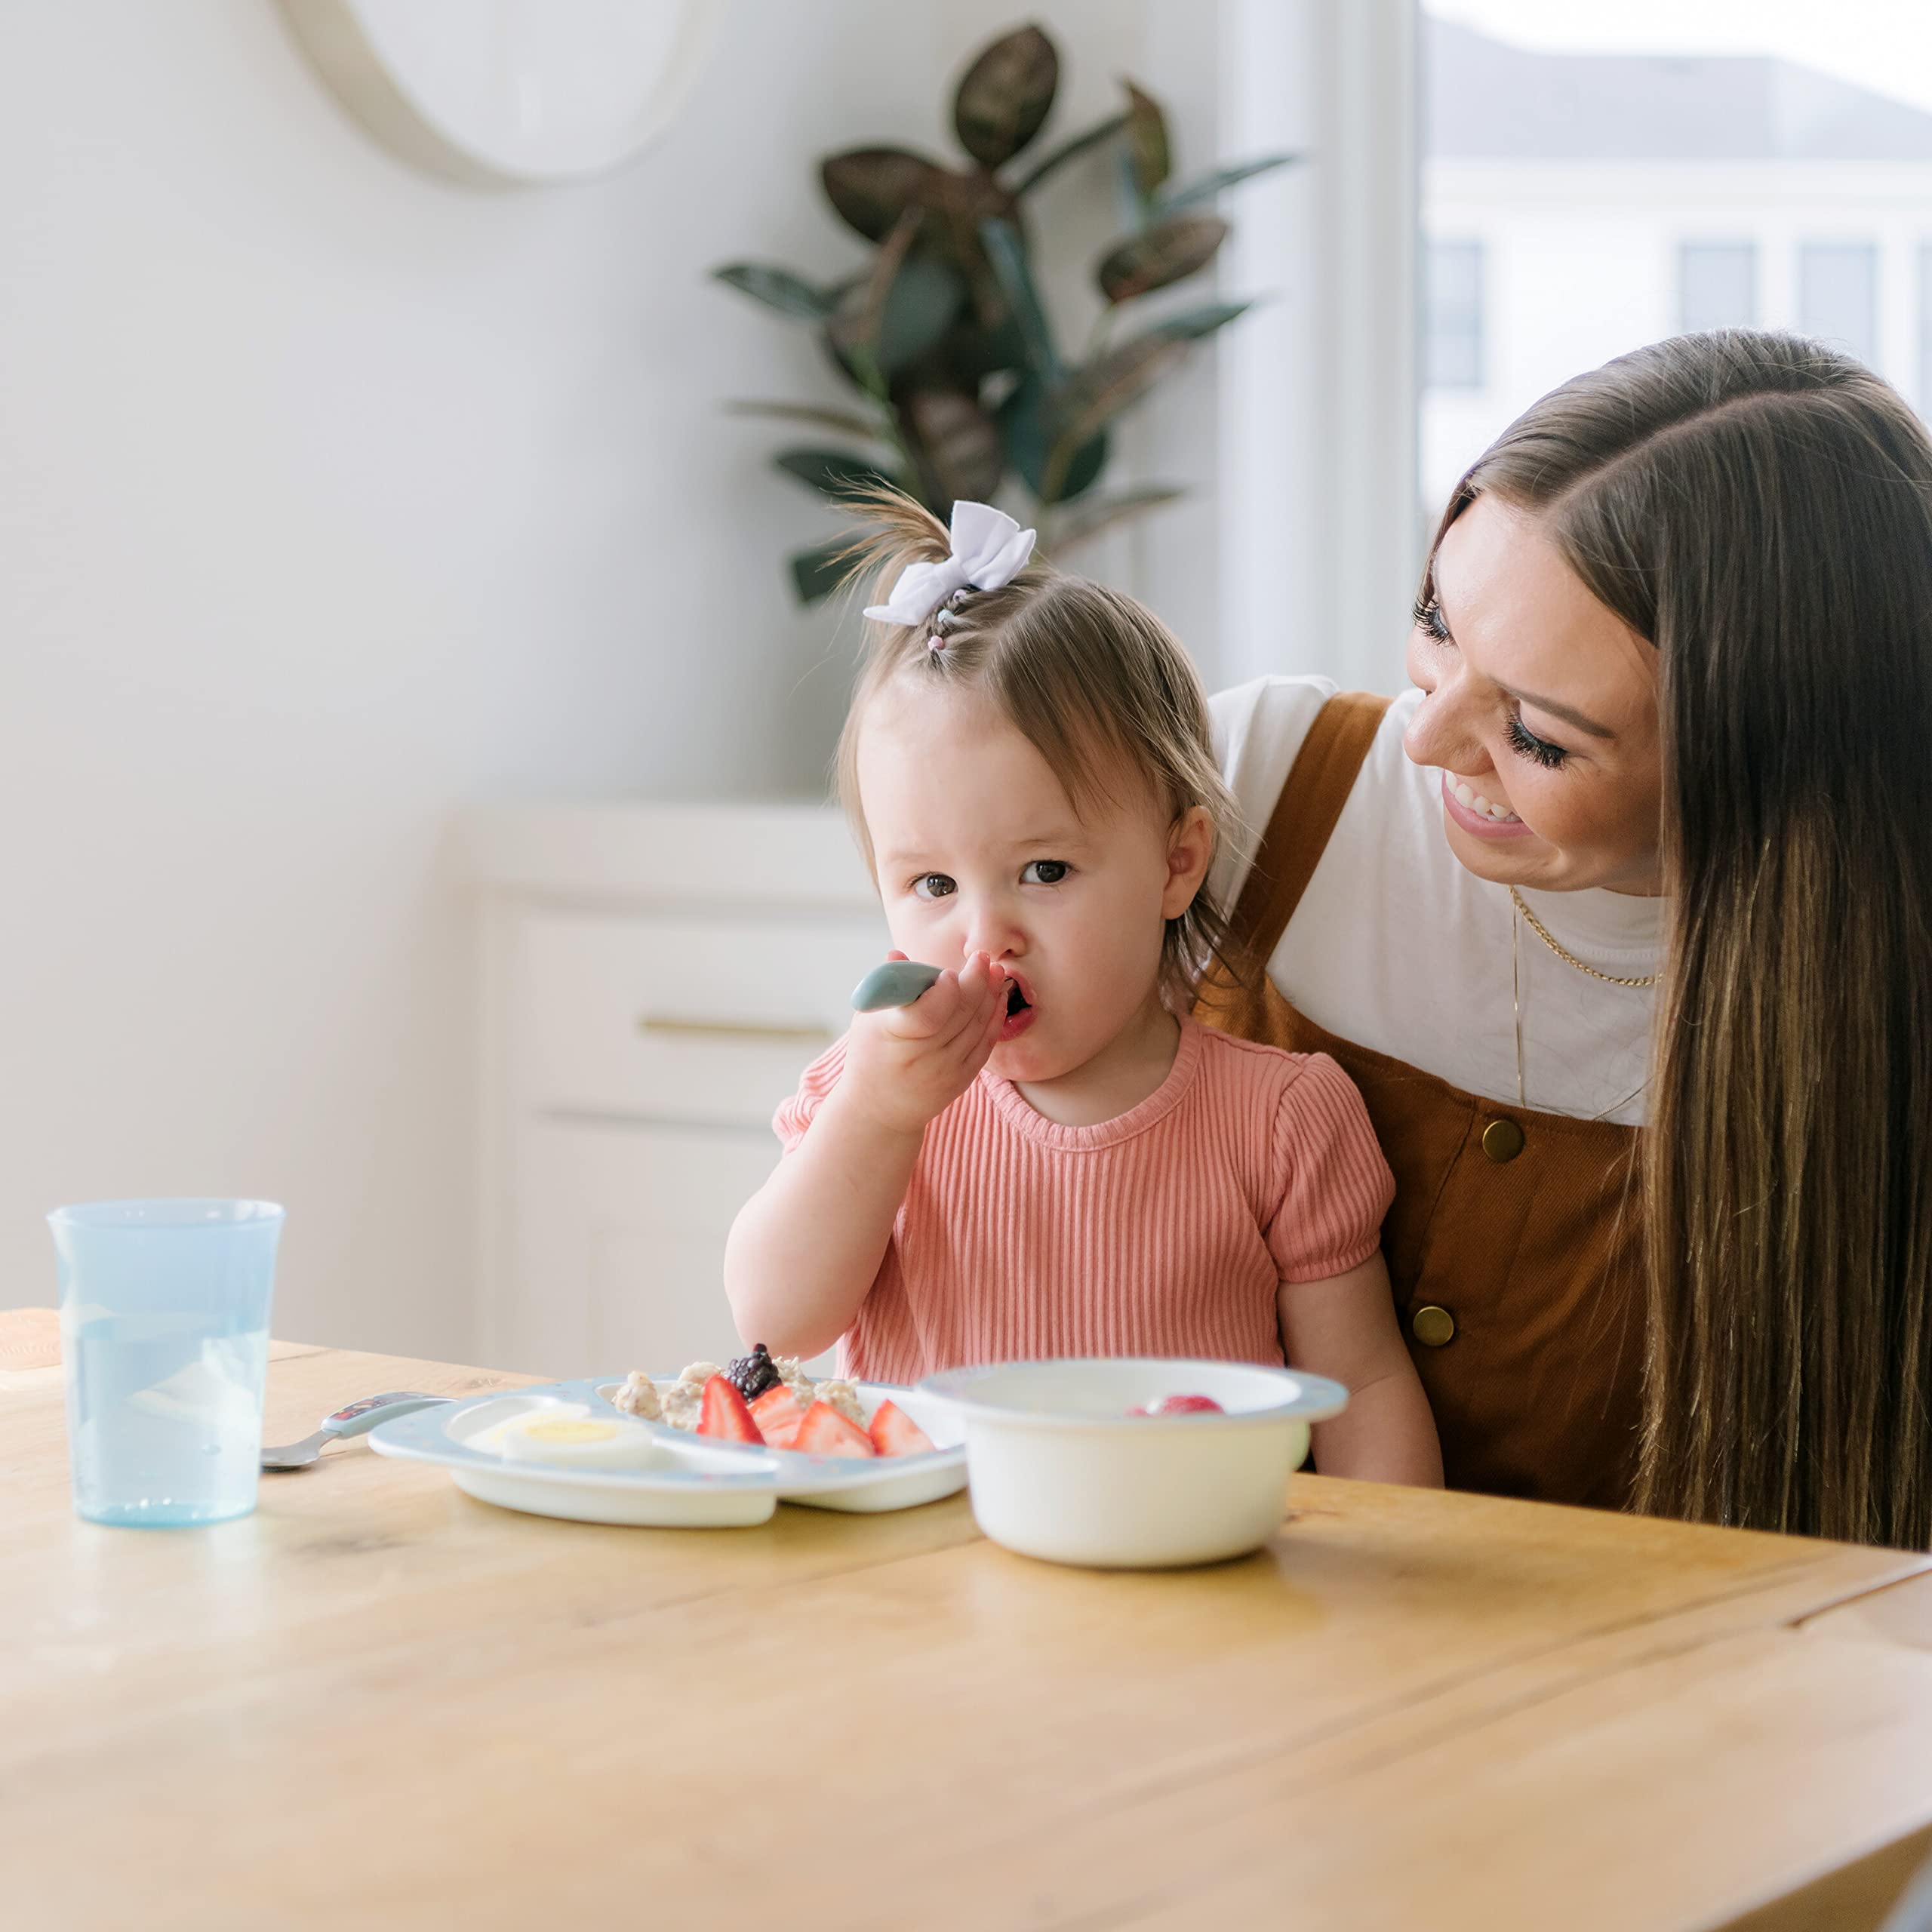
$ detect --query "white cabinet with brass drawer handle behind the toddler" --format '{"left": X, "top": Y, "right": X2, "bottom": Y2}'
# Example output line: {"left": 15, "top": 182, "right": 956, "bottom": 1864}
{"left": 466, "top": 806, "right": 887, "bottom": 1376}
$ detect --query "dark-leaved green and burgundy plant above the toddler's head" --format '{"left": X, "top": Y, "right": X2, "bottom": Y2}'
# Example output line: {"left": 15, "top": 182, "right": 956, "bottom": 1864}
{"left": 715, "top": 27, "right": 1297, "bottom": 603}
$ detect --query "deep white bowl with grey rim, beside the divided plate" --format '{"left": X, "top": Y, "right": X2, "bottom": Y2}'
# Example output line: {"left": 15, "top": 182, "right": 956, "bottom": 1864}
{"left": 920, "top": 1358, "right": 1349, "bottom": 1569}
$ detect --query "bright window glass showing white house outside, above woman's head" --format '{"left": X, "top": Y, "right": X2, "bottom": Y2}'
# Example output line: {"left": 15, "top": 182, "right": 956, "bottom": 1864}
{"left": 1418, "top": 0, "right": 1932, "bottom": 513}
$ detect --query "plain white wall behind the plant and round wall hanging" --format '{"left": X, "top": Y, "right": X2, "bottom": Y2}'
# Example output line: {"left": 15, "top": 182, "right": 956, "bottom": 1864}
{"left": 0, "top": 0, "right": 1236, "bottom": 1355}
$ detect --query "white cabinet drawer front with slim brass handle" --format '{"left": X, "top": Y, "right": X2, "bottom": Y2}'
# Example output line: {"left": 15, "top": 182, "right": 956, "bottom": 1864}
{"left": 510, "top": 912, "right": 889, "bottom": 1126}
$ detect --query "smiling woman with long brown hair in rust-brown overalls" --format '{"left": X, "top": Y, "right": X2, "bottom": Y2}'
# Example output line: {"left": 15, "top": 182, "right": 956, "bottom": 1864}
{"left": 1201, "top": 331, "right": 1932, "bottom": 1548}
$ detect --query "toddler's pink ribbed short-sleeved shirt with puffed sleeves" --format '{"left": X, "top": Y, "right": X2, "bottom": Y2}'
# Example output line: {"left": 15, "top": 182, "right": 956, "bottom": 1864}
{"left": 773, "top": 1020, "right": 1395, "bottom": 1381}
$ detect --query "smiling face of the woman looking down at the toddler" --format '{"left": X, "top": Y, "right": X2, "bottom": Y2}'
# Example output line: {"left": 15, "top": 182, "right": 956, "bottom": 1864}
{"left": 1404, "top": 494, "right": 1663, "bottom": 894}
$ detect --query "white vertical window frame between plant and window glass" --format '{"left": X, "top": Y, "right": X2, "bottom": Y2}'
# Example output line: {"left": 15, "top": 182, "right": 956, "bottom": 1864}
{"left": 1213, "top": 0, "right": 1422, "bottom": 691}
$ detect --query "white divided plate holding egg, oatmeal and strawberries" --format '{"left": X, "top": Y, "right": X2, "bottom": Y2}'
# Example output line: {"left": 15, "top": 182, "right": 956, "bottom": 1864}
{"left": 369, "top": 1376, "right": 966, "bottom": 1528}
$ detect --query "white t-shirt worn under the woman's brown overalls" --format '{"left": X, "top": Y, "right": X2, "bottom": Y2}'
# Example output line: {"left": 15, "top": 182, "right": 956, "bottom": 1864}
{"left": 1211, "top": 678, "right": 1663, "bottom": 1124}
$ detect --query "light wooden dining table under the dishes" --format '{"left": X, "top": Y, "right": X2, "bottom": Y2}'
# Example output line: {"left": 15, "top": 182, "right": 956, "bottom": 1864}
{"left": 0, "top": 1318, "right": 1932, "bottom": 1932}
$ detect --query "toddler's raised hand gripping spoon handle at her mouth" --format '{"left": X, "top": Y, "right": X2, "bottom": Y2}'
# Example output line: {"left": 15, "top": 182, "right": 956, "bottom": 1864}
{"left": 838, "top": 952, "right": 1007, "bottom": 1134}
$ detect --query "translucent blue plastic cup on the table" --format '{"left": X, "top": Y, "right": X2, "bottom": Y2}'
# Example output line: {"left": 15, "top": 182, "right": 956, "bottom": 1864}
{"left": 46, "top": 1200, "right": 284, "bottom": 1528}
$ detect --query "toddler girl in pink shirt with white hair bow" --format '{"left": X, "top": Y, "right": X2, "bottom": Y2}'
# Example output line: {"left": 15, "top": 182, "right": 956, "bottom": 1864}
{"left": 724, "top": 498, "right": 1441, "bottom": 1484}
